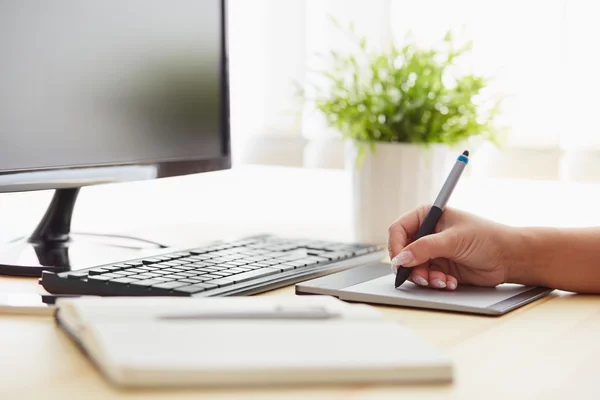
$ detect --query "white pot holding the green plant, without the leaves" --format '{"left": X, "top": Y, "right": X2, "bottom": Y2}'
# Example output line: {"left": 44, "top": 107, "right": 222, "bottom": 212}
{"left": 346, "top": 141, "right": 451, "bottom": 244}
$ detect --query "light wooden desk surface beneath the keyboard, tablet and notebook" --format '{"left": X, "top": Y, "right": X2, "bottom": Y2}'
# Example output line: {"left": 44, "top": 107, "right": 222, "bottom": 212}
{"left": 0, "top": 167, "right": 600, "bottom": 399}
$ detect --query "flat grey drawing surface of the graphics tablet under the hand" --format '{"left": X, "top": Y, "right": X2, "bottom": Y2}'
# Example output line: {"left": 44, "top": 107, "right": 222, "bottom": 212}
{"left": 342, "top": 274, "right": 531, "bottom": 308}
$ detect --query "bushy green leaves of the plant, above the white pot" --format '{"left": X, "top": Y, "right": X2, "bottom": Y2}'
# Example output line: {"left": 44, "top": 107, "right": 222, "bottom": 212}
{"left": 302, "top": 26, "right": 500, "bottom": 152}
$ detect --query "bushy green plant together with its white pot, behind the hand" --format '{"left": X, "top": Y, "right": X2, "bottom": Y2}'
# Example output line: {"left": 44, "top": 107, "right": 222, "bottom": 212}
{"left": 303, "top": 29, "right": 500, "bottom": 243}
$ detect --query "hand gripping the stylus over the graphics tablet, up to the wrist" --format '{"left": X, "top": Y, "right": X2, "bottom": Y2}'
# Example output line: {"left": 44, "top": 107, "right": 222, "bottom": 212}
{"left": 388, "top": 206, "right": 514, "bottom": 290}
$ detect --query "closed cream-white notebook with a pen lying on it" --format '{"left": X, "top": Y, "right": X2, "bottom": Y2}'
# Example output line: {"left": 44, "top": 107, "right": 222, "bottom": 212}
{"left": 57, "top": 296, "right": 452, "bottom": 387}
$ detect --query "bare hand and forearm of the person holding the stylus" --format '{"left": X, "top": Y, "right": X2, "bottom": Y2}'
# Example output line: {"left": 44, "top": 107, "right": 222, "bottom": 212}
{"left": 388, "top": 206, "right": 600, "bottom": 293}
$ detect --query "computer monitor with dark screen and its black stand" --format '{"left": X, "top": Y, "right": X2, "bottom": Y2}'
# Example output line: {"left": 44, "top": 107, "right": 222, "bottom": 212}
{"left": 0, "top": 0, "right": 231, "bottom": 276}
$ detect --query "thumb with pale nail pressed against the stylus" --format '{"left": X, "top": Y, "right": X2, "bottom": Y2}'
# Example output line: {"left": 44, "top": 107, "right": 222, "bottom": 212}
{"left": 392, "top": 231, "right": 456, "bottom": 268}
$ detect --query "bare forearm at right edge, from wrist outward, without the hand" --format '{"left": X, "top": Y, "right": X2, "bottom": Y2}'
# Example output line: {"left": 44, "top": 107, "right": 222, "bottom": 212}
{"left": 507, "top": 228, "right": 600, "bottom": 293}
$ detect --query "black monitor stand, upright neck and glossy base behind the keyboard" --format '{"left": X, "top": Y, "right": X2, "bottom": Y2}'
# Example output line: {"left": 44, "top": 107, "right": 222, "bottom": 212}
{"left": 0, "top": 188, "right": 166, "bottom": 277}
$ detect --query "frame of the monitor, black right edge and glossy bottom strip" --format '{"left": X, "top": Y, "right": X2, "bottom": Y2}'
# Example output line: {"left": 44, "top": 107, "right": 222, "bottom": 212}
{"left": 0, "top": 0, "right": 231, "bottom": 193}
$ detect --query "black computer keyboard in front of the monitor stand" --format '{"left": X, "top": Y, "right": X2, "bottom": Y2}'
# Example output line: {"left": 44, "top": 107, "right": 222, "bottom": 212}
{"left": 40, "top": 235, "right": 384, "bottom": 296}
